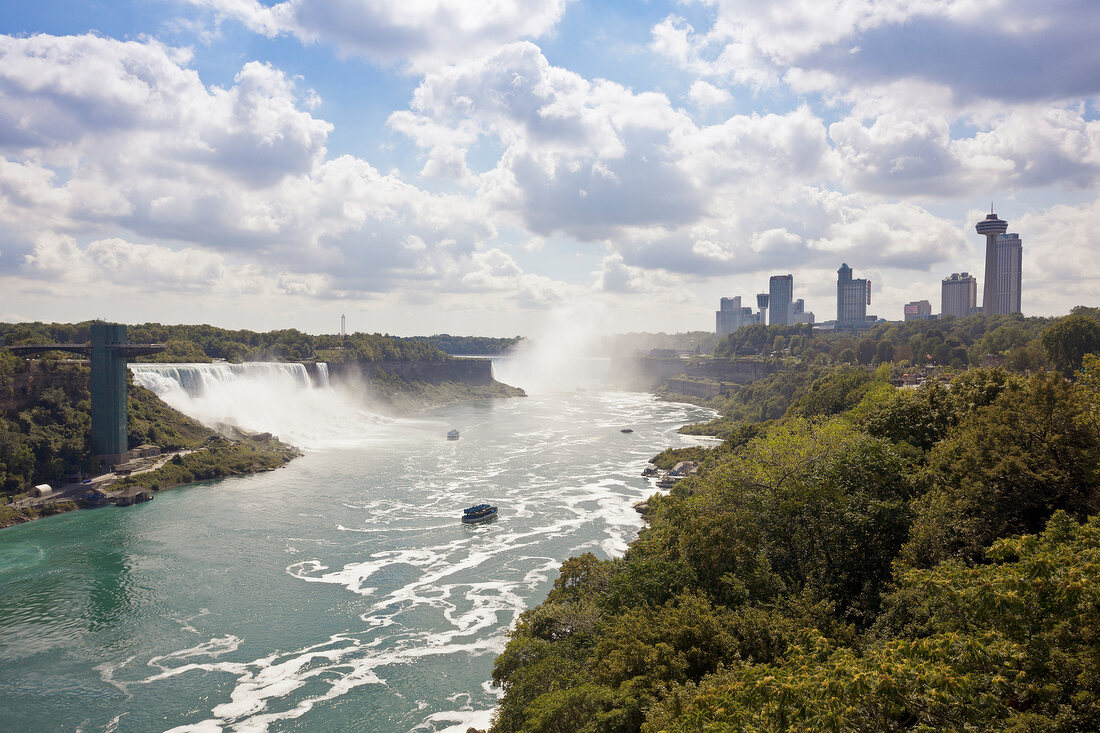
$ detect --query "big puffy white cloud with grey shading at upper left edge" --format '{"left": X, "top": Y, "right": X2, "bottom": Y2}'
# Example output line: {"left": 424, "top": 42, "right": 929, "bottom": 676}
{"left": 0, "top": 34, "right": 332, "bottom": 185}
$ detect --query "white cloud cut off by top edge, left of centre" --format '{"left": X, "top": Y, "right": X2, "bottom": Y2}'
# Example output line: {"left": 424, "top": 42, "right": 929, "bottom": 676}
{"left": 184, "top": 0, "right": 570, "bottom": 70}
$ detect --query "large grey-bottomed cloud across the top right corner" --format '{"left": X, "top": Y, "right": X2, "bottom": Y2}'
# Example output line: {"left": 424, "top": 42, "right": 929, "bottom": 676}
{"left": 652, "top": 0, "right": 1100, "bottom": 102}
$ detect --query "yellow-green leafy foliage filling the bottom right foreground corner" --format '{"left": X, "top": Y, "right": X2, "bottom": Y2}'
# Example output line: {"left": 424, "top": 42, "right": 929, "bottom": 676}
{"left": 642, "top": 514, "right": 1100, "bottom": 733}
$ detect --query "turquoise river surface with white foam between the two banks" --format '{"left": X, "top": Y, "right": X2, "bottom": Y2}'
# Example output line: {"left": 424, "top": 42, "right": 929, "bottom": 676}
{"left": 0, "top": 392, "right": 710, "bottom": 733}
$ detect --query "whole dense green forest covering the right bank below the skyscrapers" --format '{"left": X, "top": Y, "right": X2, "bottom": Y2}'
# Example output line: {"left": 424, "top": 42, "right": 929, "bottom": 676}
{"left": 492, "top": 308, "right": 1100, "bottom": 733}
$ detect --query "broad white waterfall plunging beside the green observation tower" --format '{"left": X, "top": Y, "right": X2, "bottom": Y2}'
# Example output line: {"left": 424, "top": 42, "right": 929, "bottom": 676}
{"left": 130, "top": 362, "right": 386, "bottom": 448}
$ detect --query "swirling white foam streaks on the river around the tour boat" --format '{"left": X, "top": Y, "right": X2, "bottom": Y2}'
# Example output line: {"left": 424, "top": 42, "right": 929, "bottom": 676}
{"left": 101, "top": 385, "right": 721, "bottom": 733}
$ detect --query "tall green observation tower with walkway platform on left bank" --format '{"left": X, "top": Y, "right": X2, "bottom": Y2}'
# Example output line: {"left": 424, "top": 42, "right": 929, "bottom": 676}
{"left": 8, "top": 322, "right": 164, "bottom": 463}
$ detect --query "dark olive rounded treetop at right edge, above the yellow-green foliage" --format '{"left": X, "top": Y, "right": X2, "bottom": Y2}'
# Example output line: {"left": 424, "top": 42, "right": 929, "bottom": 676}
{"left": 901, "top": 373, "right": 1100, "bottom": 567}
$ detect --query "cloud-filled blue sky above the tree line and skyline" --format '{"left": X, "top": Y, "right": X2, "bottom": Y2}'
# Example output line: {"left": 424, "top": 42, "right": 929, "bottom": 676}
{"left": 0, "top": 0, "right": 1100, "bottom": 336}
